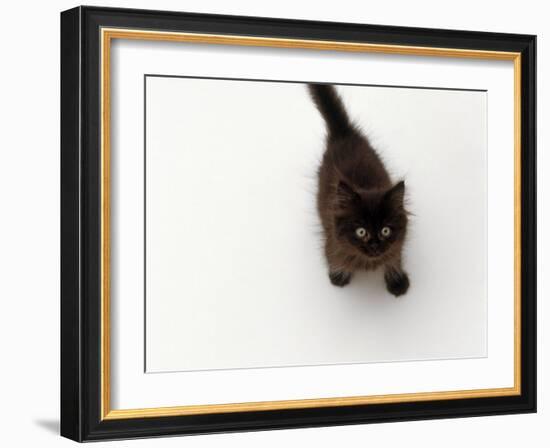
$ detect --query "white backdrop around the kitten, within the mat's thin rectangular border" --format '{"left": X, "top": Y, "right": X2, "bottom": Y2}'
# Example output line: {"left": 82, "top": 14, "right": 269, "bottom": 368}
{"left": 144, "top": 78, "right": 490, "bottom": 372}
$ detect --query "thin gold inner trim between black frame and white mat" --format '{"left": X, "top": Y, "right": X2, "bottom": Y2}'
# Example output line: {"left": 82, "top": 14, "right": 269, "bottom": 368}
{"left": 100, "top": 28, "right": 521, "bottom": 420}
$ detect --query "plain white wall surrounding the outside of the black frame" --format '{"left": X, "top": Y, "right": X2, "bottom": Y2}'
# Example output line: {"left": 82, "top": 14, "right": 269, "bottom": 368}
{"left": 0, "top": 0, "right": 550, "bottom": 447}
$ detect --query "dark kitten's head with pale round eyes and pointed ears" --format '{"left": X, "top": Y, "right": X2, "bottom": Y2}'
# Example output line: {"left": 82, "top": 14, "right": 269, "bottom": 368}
{"left": 335, "top": 181, "right": 407, "bottom": 261}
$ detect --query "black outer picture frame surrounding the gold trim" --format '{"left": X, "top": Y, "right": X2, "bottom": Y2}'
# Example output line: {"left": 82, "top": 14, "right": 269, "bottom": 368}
{"left": 61, "top": 7, "right": 536, "bottom": 442}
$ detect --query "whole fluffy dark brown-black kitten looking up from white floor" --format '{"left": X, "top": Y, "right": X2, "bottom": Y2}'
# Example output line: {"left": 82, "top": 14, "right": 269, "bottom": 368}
{"left": 309, "top": 84, "right": 409, "bottom": 296}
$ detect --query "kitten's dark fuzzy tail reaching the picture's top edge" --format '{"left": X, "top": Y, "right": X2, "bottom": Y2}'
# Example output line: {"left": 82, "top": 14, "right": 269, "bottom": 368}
{"left": 309, "top": 84, "right": 353, "bottom": 137}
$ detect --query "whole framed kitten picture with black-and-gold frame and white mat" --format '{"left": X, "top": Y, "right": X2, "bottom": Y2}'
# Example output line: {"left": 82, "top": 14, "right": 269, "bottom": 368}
{"left": 61, "top": 7, "right": 536, "bottom": 441}
